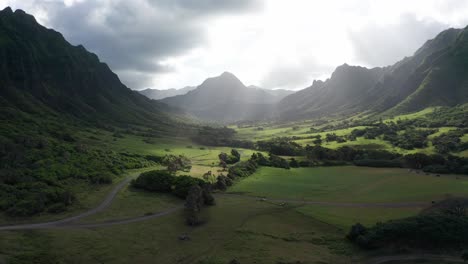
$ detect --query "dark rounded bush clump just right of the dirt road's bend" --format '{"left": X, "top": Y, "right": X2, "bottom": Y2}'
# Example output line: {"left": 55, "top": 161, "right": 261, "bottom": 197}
{"left": 132, "top": 170, "right": 174, "bottom": 192}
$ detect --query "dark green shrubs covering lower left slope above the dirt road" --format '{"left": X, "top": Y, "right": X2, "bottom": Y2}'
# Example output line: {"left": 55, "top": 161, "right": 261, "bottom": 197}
{"left": 0, "top": 127, "right": 161, "bottom": 216}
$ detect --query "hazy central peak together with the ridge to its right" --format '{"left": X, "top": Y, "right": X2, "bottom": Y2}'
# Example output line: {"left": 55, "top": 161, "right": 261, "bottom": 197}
{"left": 156, "top": 25, "right": 468, "bottom": 122}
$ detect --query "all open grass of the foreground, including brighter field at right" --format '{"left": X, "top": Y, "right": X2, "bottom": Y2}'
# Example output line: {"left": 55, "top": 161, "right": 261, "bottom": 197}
{"left": 0, "top": 164, "right": 468, "bottom": 264}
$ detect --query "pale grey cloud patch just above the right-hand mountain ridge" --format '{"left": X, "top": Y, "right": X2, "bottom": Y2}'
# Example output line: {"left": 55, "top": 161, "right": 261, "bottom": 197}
{"left": 349, "top": 14, "right": 448, "bottom": 66}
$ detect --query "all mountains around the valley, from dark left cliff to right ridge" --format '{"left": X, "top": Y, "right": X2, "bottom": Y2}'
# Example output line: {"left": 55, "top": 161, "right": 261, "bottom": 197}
{"left": 0, "top": 8, "right": 468, "bottom": 126}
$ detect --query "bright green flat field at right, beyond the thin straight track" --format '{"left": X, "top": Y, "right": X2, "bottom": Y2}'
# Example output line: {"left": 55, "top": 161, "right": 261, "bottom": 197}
{"left": 230, "top": 166, "right": 468, "bottom": 202}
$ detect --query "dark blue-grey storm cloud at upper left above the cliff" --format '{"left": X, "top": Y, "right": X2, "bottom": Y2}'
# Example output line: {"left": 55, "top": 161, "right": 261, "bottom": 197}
{"left": 31, "top": 0, "right": 260, "bottom": 88}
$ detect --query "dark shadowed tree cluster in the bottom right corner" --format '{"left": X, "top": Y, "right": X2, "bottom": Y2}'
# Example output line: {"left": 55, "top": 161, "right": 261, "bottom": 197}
{"left": 347, "top": 200, "right": 468, "bottom": 249}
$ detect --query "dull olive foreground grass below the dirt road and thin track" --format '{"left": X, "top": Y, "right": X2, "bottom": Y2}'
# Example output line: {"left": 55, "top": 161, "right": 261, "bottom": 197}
{"left": 0, "top": 193, "right": 362, "bottom": 264}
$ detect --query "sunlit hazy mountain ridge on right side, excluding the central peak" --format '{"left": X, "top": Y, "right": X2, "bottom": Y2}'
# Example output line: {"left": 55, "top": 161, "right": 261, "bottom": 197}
{"left": 278, "top": 26, "right": 468, "bottom": 120}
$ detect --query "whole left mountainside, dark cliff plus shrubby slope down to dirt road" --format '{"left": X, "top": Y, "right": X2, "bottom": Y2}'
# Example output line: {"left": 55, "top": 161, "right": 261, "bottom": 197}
{"left": 0, "top": 8, "right": 190, "bottom": 216}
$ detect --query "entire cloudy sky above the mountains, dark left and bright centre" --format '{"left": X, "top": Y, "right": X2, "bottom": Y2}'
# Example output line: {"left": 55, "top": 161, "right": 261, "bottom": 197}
{"left": 0, "top": 0, "right": 468, "bottom": 89}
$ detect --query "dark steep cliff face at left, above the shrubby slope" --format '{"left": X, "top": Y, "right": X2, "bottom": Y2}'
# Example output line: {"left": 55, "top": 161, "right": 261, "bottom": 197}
{"left": 0, "top": 5, "right": 179, "bottom": 126}
